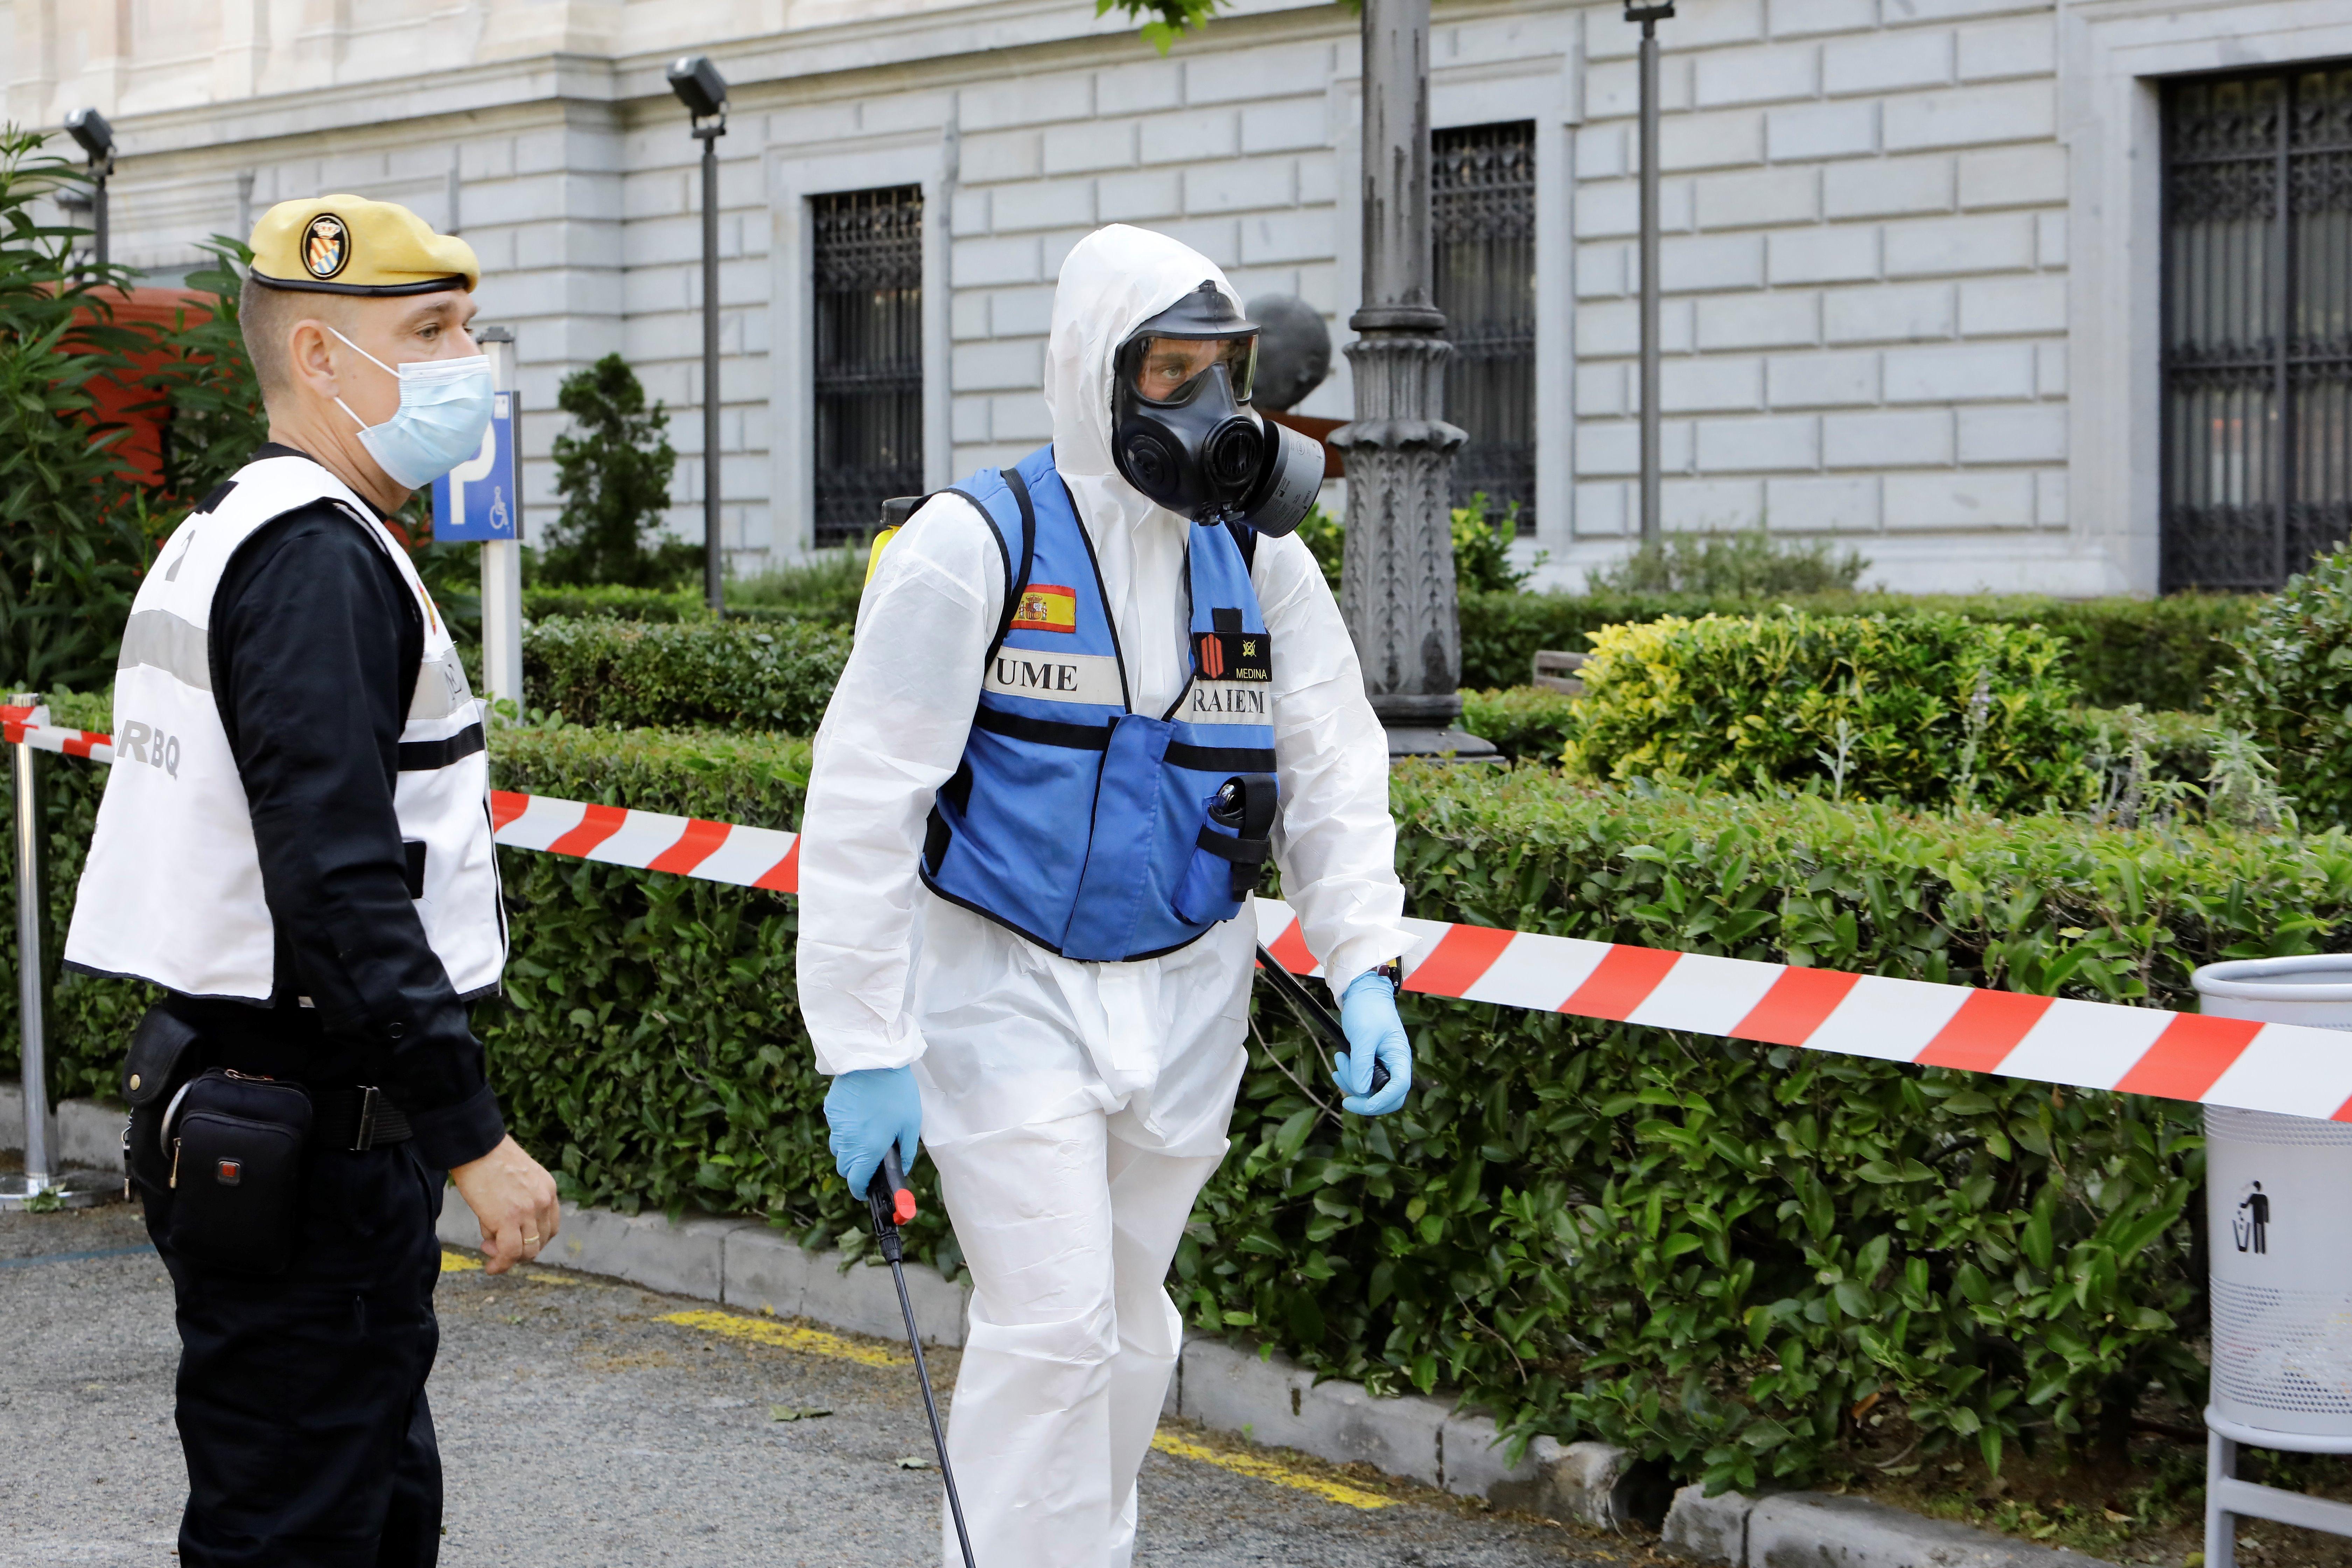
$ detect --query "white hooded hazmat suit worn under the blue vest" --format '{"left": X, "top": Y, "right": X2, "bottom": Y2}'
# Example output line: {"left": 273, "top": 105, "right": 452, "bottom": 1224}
{"left": 800, "top": 226, "right": 1409, "bottom": 1568}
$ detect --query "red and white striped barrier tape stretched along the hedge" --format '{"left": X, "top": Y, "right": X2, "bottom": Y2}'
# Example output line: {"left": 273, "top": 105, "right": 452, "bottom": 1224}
{"left": 14, "top": 708, "right": 2352, "bottom": 1121}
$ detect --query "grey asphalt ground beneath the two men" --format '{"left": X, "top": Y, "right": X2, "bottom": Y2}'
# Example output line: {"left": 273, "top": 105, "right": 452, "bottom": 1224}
{"left": 0, "top": 1204, "right": 1649, "bottom": 1568}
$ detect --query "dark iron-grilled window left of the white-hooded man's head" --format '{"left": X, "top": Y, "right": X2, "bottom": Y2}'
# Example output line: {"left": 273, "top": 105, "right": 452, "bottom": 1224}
{"left": 809, "top": 186, "right": 922, "bottom": 545}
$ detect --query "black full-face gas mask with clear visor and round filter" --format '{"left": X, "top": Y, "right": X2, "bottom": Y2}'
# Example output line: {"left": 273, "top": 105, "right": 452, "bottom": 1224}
{"left": 1110, "top": 282, "right": 1324, "bottom": 536}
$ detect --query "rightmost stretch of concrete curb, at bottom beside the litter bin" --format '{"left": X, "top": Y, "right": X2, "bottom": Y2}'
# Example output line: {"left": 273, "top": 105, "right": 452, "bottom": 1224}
{"left": 1660, "top": 1486, "right": 2114, "bottom": 1568}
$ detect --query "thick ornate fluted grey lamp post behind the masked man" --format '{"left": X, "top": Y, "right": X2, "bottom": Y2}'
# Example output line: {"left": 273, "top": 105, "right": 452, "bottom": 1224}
{"left": 1329, "top": 0, "right": 1493, "bottom": 757}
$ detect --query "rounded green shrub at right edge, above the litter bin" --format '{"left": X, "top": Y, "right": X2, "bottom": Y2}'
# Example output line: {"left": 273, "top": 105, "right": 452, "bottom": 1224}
{"left": 2213, "top": 552, "right": 2352, "bottom": 823}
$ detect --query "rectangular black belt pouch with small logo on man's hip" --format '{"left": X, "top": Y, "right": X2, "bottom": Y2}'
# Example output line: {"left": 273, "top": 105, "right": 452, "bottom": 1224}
{"left": 164, "top": 1067, "right": 310, "bottom": 1274}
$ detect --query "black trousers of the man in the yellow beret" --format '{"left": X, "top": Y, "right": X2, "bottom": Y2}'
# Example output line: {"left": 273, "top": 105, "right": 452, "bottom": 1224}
{"left": 146, "top": 1142, "right": 442, "bottom": 1568}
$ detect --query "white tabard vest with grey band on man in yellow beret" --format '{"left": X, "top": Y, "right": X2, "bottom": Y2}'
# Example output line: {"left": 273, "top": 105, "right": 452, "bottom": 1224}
{"left": 66, "top": 456, "right": 506, "bottom": 1001}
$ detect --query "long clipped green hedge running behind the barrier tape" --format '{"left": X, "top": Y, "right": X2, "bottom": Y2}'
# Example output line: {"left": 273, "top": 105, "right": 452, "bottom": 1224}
{"left": 23, "top": 726, "right": 2352, "bottom": 1486}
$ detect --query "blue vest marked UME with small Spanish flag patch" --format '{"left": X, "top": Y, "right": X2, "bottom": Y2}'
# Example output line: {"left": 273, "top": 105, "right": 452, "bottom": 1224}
{"left": 922, "top": 447, "right": 1275, "bottom": 961}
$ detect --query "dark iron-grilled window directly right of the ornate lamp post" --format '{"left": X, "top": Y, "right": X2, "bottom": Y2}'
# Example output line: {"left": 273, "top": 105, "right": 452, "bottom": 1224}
{"left": 1430, "top": 120, "right": 1536, "bottom": 534}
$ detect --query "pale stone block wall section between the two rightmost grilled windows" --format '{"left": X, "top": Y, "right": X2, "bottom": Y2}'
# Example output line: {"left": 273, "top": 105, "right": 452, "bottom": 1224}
{"left": 1576, "top": 0, "right": 2067, "bottom": 588}
